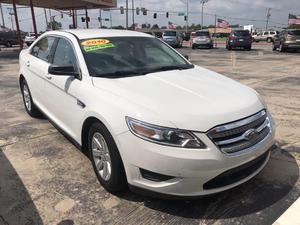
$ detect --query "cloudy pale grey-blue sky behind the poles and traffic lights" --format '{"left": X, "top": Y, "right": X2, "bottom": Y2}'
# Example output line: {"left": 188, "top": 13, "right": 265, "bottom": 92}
{"left": 0, "top": 0, "right": 300, "bottom": 31}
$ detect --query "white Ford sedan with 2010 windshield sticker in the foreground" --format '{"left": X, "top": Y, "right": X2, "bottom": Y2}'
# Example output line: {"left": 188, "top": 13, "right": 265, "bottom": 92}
{"left": 19, "top": 29, "right": 275, "bottom": 197}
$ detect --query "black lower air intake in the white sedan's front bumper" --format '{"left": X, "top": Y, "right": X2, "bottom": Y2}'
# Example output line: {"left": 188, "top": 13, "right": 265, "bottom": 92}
{"left": 203, "top": 151, "right": 269, "bottom": 190}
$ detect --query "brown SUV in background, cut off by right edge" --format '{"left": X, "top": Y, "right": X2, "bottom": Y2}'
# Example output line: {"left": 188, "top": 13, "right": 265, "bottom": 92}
{"left": 273, "top": 29, "right": 300, "bottom": 52}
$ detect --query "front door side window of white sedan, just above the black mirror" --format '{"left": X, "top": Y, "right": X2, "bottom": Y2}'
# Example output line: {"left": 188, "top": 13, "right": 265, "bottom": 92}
{"left": 53, "top": 38, "right": 77, "bottom": 67}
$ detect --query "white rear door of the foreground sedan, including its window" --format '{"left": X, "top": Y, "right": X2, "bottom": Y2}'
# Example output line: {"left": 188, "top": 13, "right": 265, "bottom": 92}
{"left": 24, "top": 36, "right": 56, "bottom": 108}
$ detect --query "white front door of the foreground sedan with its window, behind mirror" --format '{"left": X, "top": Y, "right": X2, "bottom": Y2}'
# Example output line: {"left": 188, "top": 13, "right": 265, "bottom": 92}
{"left": 45, "top": 37, "right": 85, "bottom": 139}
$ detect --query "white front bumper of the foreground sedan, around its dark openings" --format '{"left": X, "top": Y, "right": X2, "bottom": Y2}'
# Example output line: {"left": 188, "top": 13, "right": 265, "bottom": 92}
{"left": 118, "top": 112, "right": 275, "bottom": 197}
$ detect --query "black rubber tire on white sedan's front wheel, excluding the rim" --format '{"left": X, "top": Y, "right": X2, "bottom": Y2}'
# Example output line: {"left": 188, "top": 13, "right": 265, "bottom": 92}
{"left": 88, "top": 122, "right": 128, "bottom": 193}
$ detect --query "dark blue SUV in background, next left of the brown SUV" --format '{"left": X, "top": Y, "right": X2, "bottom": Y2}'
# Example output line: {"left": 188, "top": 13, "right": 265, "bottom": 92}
{"left": 226, "top": 30, "right": 252, "bottom": 51}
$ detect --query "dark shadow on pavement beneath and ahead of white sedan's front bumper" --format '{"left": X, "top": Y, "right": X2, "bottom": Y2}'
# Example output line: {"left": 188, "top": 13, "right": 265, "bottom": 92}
{"left": 119, "top": 147, "right": 300, "bottom": 224}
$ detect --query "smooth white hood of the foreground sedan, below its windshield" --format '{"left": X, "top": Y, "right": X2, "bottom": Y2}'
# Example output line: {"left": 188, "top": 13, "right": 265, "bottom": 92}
{"left": 93, "top": 66, "right": 264, "bottom": 132}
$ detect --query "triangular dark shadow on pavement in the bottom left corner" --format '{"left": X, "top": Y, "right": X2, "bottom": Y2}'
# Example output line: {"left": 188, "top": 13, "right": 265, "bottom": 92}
{"left": 0, "top": 149, "right": 43, "bottom": 225}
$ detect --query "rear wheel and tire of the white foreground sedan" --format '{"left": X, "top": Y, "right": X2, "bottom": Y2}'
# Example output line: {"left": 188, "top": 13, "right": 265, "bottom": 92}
{"left": 20, "top": 80, "right": 42, "bottom": 118}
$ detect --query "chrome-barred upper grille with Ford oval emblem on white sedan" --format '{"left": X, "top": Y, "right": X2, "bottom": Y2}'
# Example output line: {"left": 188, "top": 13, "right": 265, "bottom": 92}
{"left": 208, "top": 110, "right": 271, "bottom": 154}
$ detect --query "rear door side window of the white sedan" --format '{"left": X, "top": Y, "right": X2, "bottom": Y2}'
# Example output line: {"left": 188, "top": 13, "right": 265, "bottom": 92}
{"left": 31, "top": 37, "right": 55, "bottom": 62}
